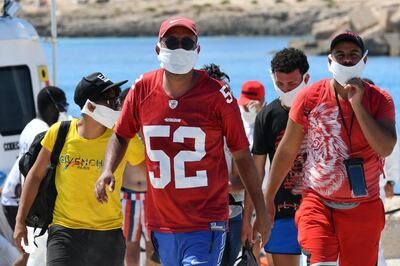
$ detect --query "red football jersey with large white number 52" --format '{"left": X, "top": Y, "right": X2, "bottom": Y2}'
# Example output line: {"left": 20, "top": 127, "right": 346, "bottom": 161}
{"left": 114, "top": 69, "right": 249, "bottom": 232}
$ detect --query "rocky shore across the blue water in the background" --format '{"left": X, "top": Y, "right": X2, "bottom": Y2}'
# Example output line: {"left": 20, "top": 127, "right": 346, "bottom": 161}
{"left": 21, "top": 0, "right": 400, "bottom": 56}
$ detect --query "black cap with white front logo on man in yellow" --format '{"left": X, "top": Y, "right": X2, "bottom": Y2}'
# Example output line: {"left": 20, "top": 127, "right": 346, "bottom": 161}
{"left": 74, "top": 72, "right": 128, "bottom": 108}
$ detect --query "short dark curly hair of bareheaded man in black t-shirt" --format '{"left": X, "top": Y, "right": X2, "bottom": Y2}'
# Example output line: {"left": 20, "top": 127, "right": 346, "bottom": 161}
{"left": 271, "top": 48, "right": 310, "bottom": 75}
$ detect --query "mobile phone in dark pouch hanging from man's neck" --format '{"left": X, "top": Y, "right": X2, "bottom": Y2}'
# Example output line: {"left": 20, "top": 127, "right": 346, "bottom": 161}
{"left": 344, "top": 158, "right": 368, "bottom": 198}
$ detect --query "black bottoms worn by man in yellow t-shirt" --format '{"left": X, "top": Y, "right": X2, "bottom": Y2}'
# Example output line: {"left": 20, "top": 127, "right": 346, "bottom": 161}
{"left": 47, "top": 225, "right": 125, "bottom": 266}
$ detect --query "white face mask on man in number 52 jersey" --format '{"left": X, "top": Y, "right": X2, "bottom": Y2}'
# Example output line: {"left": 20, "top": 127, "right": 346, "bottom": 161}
{"left": 157, "top": 44, "right": 199, "bottom": 74}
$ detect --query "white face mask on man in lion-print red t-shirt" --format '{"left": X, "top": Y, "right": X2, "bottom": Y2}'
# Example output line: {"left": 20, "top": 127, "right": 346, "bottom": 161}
{"left": 328, "top": 50, "right": 368, "bottom": 86}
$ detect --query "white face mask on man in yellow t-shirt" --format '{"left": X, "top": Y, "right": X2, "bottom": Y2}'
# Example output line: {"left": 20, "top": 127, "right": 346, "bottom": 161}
{"left": 81, "top": 100, "right": 121, "bottom": 128}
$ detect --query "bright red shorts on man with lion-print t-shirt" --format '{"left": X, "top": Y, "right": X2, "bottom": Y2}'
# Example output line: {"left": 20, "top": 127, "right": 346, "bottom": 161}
{"left": 295, "top": 194, "right": 385, "bottom": 266}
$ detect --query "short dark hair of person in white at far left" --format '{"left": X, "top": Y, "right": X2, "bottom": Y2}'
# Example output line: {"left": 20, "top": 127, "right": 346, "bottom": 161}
{"left": 37, "top": 86, "right": 67, "bottom": 117}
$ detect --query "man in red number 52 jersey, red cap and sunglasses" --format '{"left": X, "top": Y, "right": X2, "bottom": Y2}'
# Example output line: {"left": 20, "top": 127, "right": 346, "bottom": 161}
{"left": 95, "top": 17, "right": 266, "bottom": 266}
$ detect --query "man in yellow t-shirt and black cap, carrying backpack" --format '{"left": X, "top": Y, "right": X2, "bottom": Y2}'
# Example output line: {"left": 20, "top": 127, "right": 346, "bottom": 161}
{"left": 14, "top": 73, "right": 144, "bottom": 266}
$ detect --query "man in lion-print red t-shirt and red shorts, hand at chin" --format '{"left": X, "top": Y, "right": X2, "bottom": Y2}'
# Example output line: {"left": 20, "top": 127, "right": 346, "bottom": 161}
{"left": 266, "top": 32, "right": 396, "bottom": 266}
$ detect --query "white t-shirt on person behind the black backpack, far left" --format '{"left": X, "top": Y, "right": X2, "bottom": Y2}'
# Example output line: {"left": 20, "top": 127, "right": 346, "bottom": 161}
{"left": 1, "top": 118, "right": 49, "bottom": 206}
